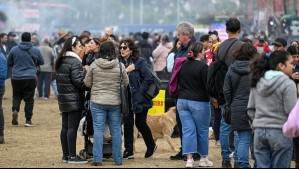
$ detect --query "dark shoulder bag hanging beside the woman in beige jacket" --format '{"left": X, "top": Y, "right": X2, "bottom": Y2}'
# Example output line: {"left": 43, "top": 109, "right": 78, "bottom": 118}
{"left": 119, "top": 62, "right": 129, "bottom": 117}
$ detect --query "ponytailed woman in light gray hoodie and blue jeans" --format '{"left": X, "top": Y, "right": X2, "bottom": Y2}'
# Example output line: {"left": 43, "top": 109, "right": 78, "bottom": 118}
{"left": 247, "top": 51, "right": 297, "bottom": 168}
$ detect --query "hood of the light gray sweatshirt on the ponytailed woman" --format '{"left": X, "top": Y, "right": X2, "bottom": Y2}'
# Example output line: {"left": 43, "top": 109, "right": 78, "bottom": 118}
{"left": 256, "top": 70, "right": 289, "bottom": 97}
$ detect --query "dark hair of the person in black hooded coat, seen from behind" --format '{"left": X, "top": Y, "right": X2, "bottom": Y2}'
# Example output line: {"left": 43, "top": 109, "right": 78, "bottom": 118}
{"left": 232, "top": 42, "right": 258, "bottom": 61}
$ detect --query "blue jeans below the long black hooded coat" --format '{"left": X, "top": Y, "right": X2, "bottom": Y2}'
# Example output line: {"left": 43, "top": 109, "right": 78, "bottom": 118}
{"left": 235, "top": 130, "right": 252, "bottom": 168}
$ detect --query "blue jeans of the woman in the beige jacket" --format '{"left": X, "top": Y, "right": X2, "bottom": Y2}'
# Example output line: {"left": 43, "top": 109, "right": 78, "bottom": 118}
{"left": 90, "top": 102, "right": 123, "bottom": 164}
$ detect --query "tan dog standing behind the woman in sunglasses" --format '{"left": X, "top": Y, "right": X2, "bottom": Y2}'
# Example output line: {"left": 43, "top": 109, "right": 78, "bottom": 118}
{"left": 134, "top": 107, "right": 177, "bottom": 151}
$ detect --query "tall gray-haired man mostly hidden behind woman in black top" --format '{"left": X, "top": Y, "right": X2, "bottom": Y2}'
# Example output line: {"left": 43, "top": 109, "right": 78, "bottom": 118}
{"left": 170, "top": 22, "right": 196, "bottom": 160}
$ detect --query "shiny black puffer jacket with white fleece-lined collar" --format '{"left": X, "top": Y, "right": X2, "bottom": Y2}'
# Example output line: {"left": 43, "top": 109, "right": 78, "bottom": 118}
{"left": 56, "top": 52, "right": 86, "bottom": 112}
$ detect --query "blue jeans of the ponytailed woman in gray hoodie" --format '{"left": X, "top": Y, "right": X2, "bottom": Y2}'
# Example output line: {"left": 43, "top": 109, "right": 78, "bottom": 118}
{"left": 254, "top": 128, "right": 293, "bottom": 168}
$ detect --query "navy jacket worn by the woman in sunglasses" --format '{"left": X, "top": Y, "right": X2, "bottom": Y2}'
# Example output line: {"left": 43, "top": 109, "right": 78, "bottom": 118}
{"left": 121, "top": 57, "right": 154, "bottom": 113}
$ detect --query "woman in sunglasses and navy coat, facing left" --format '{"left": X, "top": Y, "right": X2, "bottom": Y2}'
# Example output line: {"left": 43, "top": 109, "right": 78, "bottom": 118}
{"left": 119, "top": 38, "right": 157, "bottom": 159}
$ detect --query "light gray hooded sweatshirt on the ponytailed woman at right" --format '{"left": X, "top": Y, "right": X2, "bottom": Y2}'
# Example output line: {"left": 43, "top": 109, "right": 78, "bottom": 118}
{"left": 247, "top": 71, "right": 297, "bottom": 129}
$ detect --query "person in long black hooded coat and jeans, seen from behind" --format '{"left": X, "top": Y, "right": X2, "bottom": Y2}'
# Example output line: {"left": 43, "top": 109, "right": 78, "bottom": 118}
{"left": 223, "top": 43, "right": 257, "bottom": 168}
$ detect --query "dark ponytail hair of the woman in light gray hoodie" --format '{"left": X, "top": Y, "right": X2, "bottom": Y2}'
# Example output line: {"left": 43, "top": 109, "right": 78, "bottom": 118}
{"left": 249, "top": 51, "right": 291, "bottom": 88}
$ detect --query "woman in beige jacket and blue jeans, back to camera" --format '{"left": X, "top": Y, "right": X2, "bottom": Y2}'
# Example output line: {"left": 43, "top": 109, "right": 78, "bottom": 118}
{"left": 84, "top": 41, "right": 129, "bottom": 166}
